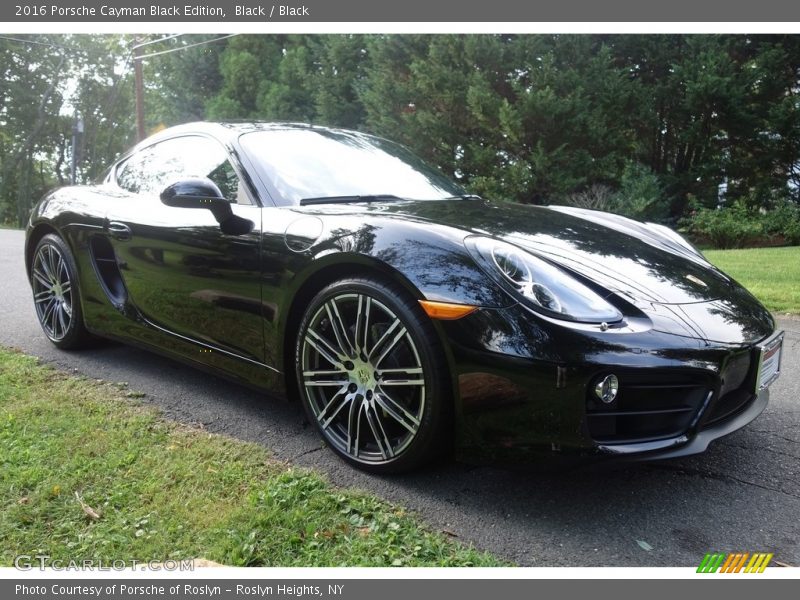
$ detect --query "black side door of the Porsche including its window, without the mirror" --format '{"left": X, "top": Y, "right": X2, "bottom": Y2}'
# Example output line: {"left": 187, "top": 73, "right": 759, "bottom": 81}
{"left": 106, "top": 135, "right": 264, "bottom": 362}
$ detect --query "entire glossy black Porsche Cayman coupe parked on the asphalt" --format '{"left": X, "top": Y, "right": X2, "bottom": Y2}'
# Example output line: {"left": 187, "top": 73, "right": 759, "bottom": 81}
{"left": 25, "top": 123, "right": 782, "bottom": 472}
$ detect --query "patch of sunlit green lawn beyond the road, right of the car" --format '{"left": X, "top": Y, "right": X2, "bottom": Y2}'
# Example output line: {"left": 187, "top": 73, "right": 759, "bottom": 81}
{"left": 703, "top": 246, "right": 800, "bottom": 315}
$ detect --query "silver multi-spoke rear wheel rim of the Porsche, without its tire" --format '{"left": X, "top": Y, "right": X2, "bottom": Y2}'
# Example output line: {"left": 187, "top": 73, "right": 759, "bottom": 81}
{"left": 31, "top": 243, "right": 72, "bottom": 342}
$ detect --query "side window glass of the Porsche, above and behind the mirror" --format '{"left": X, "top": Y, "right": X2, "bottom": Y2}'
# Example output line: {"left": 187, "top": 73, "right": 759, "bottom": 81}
{"left": 117, "top": 135, "right": 250, "bottom": 204}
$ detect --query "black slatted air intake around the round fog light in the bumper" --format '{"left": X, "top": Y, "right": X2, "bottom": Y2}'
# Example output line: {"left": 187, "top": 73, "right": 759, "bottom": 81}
{"left": 586, "top": 371, "right": 712, "bottom": 444}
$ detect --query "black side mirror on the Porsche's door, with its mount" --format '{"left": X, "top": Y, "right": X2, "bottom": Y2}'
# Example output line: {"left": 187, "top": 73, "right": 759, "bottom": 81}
{"left": 160, "top": 177, "right": 253, "bottom": 235}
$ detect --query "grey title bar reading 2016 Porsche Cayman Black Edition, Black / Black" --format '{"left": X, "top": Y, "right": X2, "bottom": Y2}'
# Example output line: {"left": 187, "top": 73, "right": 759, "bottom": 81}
{"left": 0, "top": 0, "right": 800, "bottom": 22}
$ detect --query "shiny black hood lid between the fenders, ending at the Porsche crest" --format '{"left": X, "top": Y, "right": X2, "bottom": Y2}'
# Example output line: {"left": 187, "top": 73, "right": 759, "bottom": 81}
{"left": 387, "top": 200, "right": 724, "bottom": 305}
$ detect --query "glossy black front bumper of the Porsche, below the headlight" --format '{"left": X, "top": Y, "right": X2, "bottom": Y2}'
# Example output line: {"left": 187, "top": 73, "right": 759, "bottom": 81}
{"left": 444, "top": 307, "right": 780, "bottom": 460}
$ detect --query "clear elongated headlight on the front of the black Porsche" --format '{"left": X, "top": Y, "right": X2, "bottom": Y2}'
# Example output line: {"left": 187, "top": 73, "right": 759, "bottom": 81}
{"left": 464, "top": 236, "right": 622, "bottom": 323}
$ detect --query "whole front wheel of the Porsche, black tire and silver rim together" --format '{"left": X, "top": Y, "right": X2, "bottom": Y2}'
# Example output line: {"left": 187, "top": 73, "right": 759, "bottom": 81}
{"left": 295, "top": 277, "right": 452, "bottom": 473}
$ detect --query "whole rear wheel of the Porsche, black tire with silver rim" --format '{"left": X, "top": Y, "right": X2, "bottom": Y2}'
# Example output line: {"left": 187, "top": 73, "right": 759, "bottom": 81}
{"left": 29, "top": 233, "right": 92, "bottom": 350}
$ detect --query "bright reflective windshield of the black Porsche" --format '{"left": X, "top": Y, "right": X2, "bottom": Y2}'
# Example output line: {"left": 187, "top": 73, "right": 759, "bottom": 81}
{"left": 239, "top": 128, "right": 464, "bottom": 205}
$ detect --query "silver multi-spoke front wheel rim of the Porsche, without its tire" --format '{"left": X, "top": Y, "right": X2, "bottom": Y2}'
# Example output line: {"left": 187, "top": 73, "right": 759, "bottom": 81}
{"left": 301, "top": 293, "right": 425, "bottom": 464}
